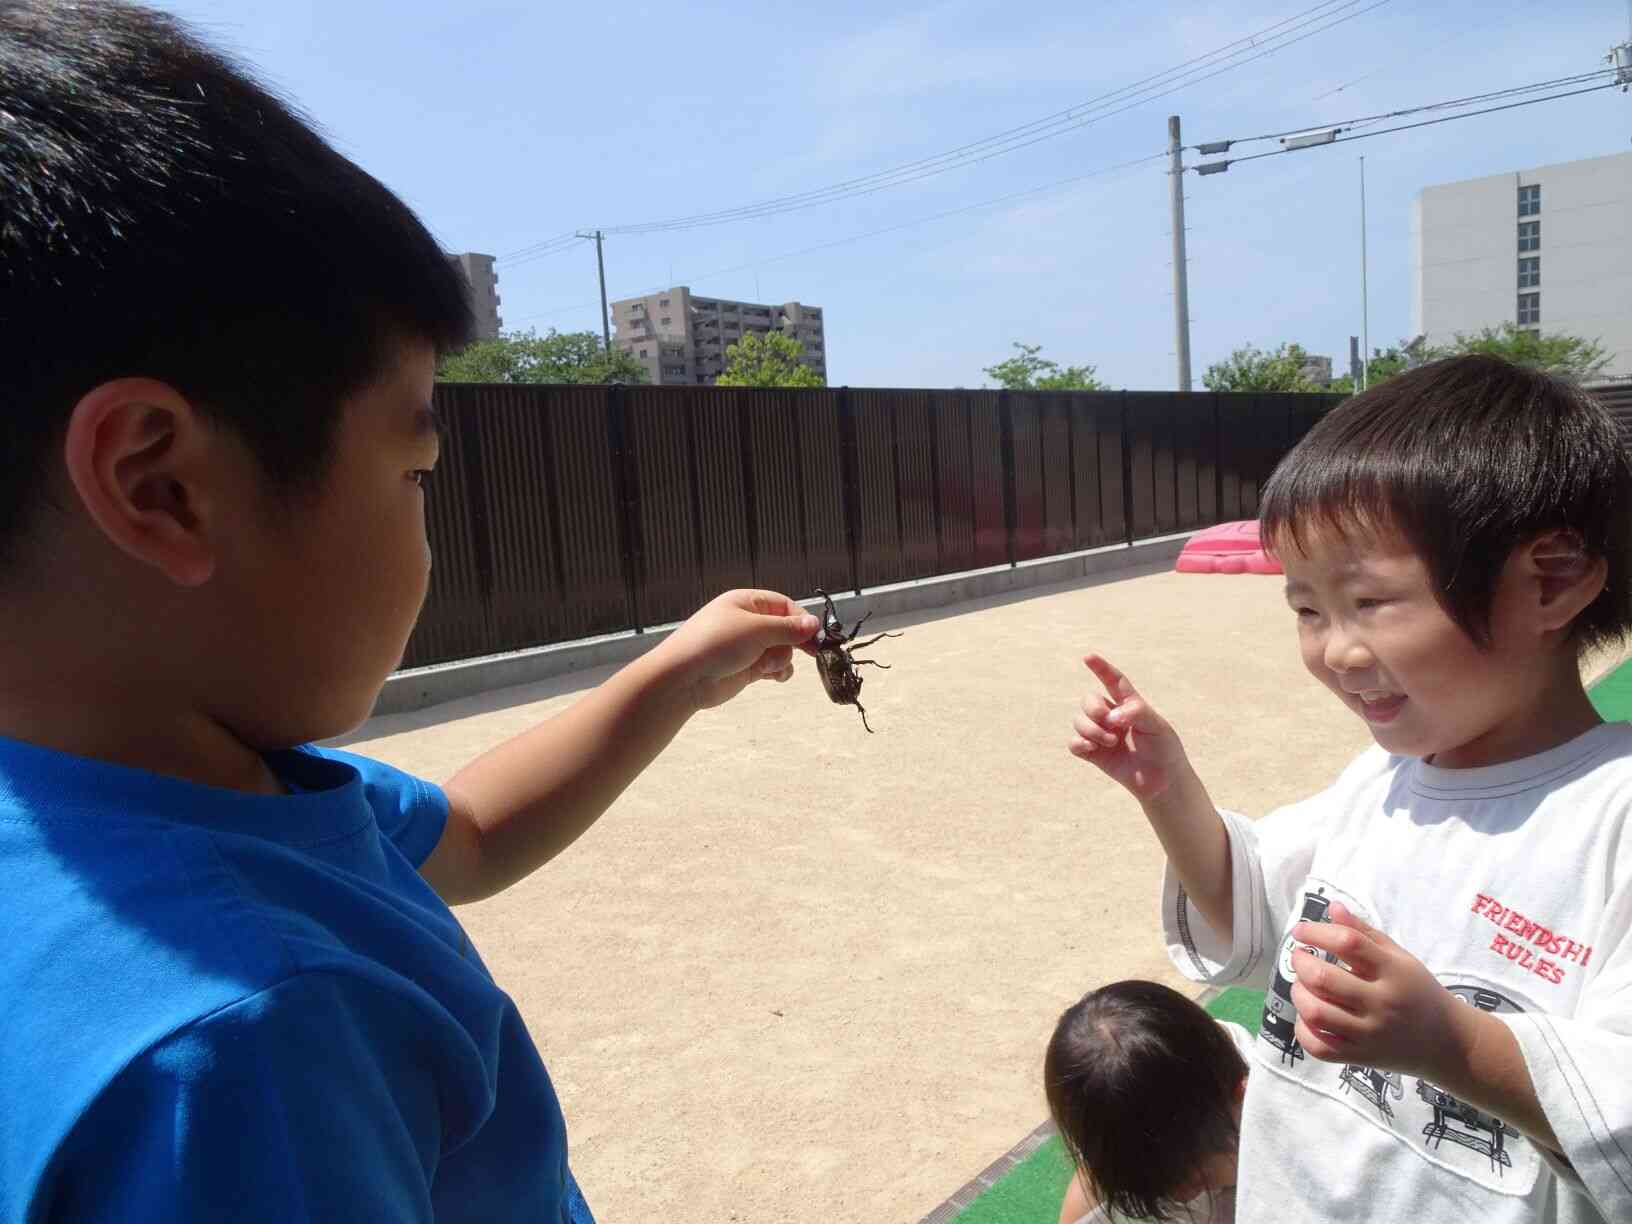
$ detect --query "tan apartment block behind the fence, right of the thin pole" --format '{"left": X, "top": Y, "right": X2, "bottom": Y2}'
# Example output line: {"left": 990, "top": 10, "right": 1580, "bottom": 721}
{"left": 612, "top": 286, "right": 827, "bottom": 387}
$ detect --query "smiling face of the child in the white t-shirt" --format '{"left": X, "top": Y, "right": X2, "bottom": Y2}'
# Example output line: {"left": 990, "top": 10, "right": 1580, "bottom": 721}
{"left": 1281, "top": 529, "right": 1553, "bottom": 769}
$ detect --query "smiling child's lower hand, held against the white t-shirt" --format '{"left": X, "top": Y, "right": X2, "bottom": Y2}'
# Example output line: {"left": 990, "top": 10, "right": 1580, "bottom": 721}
{"left": 1293, "top": 901, "right": 1483, "bottom": 1080}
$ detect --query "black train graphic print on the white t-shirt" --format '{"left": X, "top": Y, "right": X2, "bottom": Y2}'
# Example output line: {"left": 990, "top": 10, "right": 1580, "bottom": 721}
{"left": 1258, "top": 886, "right": 1541, "bottom": 1193}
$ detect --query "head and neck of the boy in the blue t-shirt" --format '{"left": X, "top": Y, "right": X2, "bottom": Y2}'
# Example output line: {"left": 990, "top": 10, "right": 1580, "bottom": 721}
{"left": 0, "top": 0, "right": 470, "bottom": 757}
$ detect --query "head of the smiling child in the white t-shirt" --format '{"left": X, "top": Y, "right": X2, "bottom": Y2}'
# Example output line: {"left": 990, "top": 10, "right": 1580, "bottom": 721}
{"left": 1258, "top": 356, "right": 1632, "bottom": 769}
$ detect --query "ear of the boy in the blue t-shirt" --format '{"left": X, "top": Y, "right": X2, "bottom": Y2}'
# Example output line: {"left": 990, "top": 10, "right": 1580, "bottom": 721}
{"left": 62, "top": 379, "right": 215, "bottom": 586}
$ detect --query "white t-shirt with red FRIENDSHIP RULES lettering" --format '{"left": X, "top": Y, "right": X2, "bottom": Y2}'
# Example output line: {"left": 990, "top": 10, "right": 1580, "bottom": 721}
{"left": 1162, "top": 723, "right": 1632, "bottom": 1224}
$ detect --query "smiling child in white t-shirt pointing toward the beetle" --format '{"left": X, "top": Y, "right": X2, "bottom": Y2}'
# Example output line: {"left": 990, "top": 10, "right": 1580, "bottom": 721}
{"left": 1071, "top": 356, "right": 1632, "bottom": 1224}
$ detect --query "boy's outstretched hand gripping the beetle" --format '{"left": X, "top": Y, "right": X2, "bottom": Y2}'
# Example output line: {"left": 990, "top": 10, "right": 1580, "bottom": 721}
{"left": 653, "top": 591, "right": 821, "bottom": 710}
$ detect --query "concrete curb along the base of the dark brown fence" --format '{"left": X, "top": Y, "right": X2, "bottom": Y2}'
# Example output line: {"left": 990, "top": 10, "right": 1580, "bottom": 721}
{"left": 372, "top": 532, "right": 1190, "bottom": 718}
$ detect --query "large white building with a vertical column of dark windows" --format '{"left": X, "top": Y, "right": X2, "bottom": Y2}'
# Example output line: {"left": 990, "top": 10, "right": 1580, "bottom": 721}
{"left": 1412, "top": 153, "right": 1632, "bottom": 375}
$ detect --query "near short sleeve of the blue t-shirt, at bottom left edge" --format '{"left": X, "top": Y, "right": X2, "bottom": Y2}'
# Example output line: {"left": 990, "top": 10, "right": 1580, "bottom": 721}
{"left": 44, "top": 973, "right": 466, "bottom": 1224}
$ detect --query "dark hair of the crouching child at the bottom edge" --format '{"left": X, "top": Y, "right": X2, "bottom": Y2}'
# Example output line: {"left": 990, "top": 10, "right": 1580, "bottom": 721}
{"left": 1043, "top": 981, "right": 1247, "bottom": 1221}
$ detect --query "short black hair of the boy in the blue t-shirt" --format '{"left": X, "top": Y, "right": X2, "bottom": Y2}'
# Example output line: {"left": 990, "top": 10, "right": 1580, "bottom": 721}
{"left": 0, "top": 0, "right": 472, "bottom": 550}
